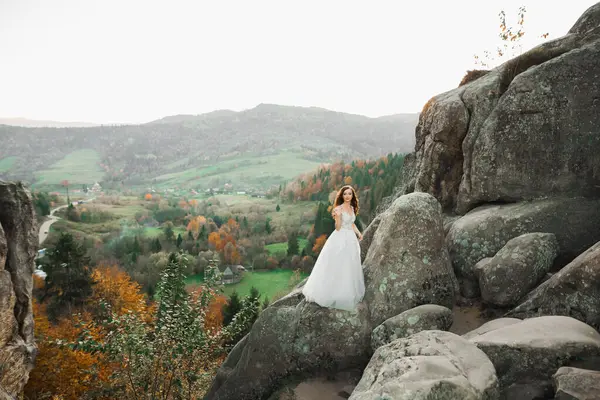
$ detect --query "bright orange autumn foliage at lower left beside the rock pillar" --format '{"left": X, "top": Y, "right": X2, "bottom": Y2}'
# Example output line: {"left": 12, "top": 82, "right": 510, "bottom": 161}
{"left": 25, "top": 266, "right": 154, "bottom": 400}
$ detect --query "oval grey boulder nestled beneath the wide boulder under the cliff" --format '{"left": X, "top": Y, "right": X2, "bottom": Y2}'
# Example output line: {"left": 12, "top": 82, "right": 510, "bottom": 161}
{"left": 475, "top": 233, "right": 558, "bottom": 307}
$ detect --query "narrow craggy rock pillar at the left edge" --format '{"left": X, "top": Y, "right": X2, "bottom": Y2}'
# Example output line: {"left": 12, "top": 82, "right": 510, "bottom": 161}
{"left": 0, "top": 182, "right": 38, "bottom": 396}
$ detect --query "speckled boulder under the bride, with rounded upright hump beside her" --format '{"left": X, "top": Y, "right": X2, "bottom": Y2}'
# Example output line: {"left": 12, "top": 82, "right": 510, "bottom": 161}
{"left": 206, "top": 193, "right": 457, "bottom": 400}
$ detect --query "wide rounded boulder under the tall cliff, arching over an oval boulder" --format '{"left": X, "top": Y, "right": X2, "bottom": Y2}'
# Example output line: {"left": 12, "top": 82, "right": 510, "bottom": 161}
{"left": 446, "top": 198, "right": 600, "bottom": 297}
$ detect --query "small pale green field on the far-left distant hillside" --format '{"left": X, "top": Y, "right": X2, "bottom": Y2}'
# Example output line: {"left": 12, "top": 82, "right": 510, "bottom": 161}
{"left": 32, "top": 149, "right": 104, "bottom": 189}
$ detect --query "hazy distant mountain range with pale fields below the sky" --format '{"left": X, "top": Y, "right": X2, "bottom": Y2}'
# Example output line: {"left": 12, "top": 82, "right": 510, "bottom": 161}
{"left": 0, "top": 104, "right": 419, "bottom": 191}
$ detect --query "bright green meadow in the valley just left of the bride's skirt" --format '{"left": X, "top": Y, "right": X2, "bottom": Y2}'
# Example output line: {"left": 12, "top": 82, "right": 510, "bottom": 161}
{"left": 186, "top": 269, "right": 308, "bottom": 300}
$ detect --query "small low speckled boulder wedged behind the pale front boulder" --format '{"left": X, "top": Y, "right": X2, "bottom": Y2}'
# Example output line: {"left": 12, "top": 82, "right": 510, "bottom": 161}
{"left": 371, "top": 304, "right": 453, "bottom": 350}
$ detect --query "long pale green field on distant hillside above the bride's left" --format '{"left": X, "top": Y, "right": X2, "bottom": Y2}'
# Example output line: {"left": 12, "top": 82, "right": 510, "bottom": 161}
{"left": 151, "top": 151, "right": 321, "bottom": 188}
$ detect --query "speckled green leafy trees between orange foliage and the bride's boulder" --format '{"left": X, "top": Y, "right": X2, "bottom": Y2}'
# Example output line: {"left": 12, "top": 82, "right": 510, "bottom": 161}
{"left": 75, "top": 253, "right": 224, "bottom": 399}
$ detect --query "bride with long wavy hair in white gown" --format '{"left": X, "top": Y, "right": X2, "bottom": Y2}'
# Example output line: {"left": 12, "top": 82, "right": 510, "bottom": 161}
{"left": 302, "top": 185, "right": 365, "bottom": 311}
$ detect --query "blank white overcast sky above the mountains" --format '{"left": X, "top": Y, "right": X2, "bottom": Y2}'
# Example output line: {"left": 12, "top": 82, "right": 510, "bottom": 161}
{"left": 0, "top": 0, "right": 597, "bottom": 123}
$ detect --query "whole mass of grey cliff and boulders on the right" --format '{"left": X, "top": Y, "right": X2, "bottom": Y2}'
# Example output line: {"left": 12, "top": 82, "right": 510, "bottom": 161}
{"left": 206, "top": 3, "right": 600, "bottom": 400}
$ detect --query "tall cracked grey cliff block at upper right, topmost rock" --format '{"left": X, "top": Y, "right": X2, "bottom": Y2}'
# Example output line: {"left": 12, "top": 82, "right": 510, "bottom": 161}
{"left": 400, "top": 4, "right": 600, "bottom": 214}
